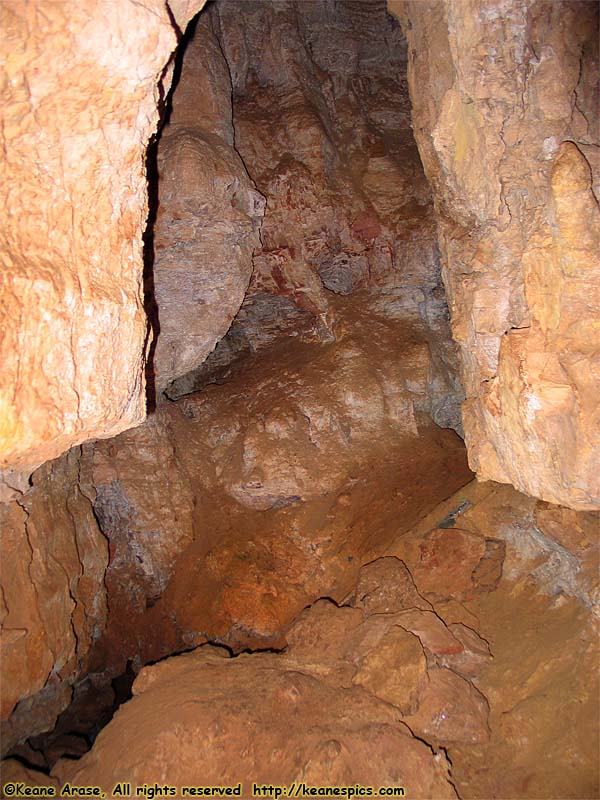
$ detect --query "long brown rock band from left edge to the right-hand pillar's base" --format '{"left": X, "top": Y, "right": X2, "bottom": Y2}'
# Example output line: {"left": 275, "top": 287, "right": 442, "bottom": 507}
{"left": 0, "top": 296, "right": 471, "bottom": 749}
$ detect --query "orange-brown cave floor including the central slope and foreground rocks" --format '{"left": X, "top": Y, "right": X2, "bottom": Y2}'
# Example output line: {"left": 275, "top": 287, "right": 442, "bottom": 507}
{"left": 3, "top": 304, "right": 600, "bottom": 800}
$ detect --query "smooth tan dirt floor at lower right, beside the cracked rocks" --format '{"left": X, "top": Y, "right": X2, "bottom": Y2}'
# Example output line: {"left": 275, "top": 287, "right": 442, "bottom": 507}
{"left": 388, "top": 481, "right": 600, "bottom": 800}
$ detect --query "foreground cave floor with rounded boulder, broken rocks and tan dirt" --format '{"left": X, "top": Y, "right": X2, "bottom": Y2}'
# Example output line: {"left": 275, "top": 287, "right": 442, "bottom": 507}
{"left": 3, "top": 481, "right": 599, "bottom": 800}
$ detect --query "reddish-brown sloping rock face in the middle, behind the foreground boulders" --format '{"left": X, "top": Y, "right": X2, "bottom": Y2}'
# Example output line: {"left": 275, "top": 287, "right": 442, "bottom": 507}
{"left": 84, "top": 296, "right": 469, "bottom": 670}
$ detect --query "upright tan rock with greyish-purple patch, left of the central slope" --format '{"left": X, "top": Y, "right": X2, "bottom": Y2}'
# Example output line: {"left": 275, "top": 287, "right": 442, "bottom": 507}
{"left": 83, "top": 413, "right": 194, "bottom": 676}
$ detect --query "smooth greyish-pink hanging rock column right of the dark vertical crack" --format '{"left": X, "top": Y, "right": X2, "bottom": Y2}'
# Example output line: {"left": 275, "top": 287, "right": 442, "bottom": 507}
{"left": 153, "top": 14, "right": 265, "bottom": 391}
